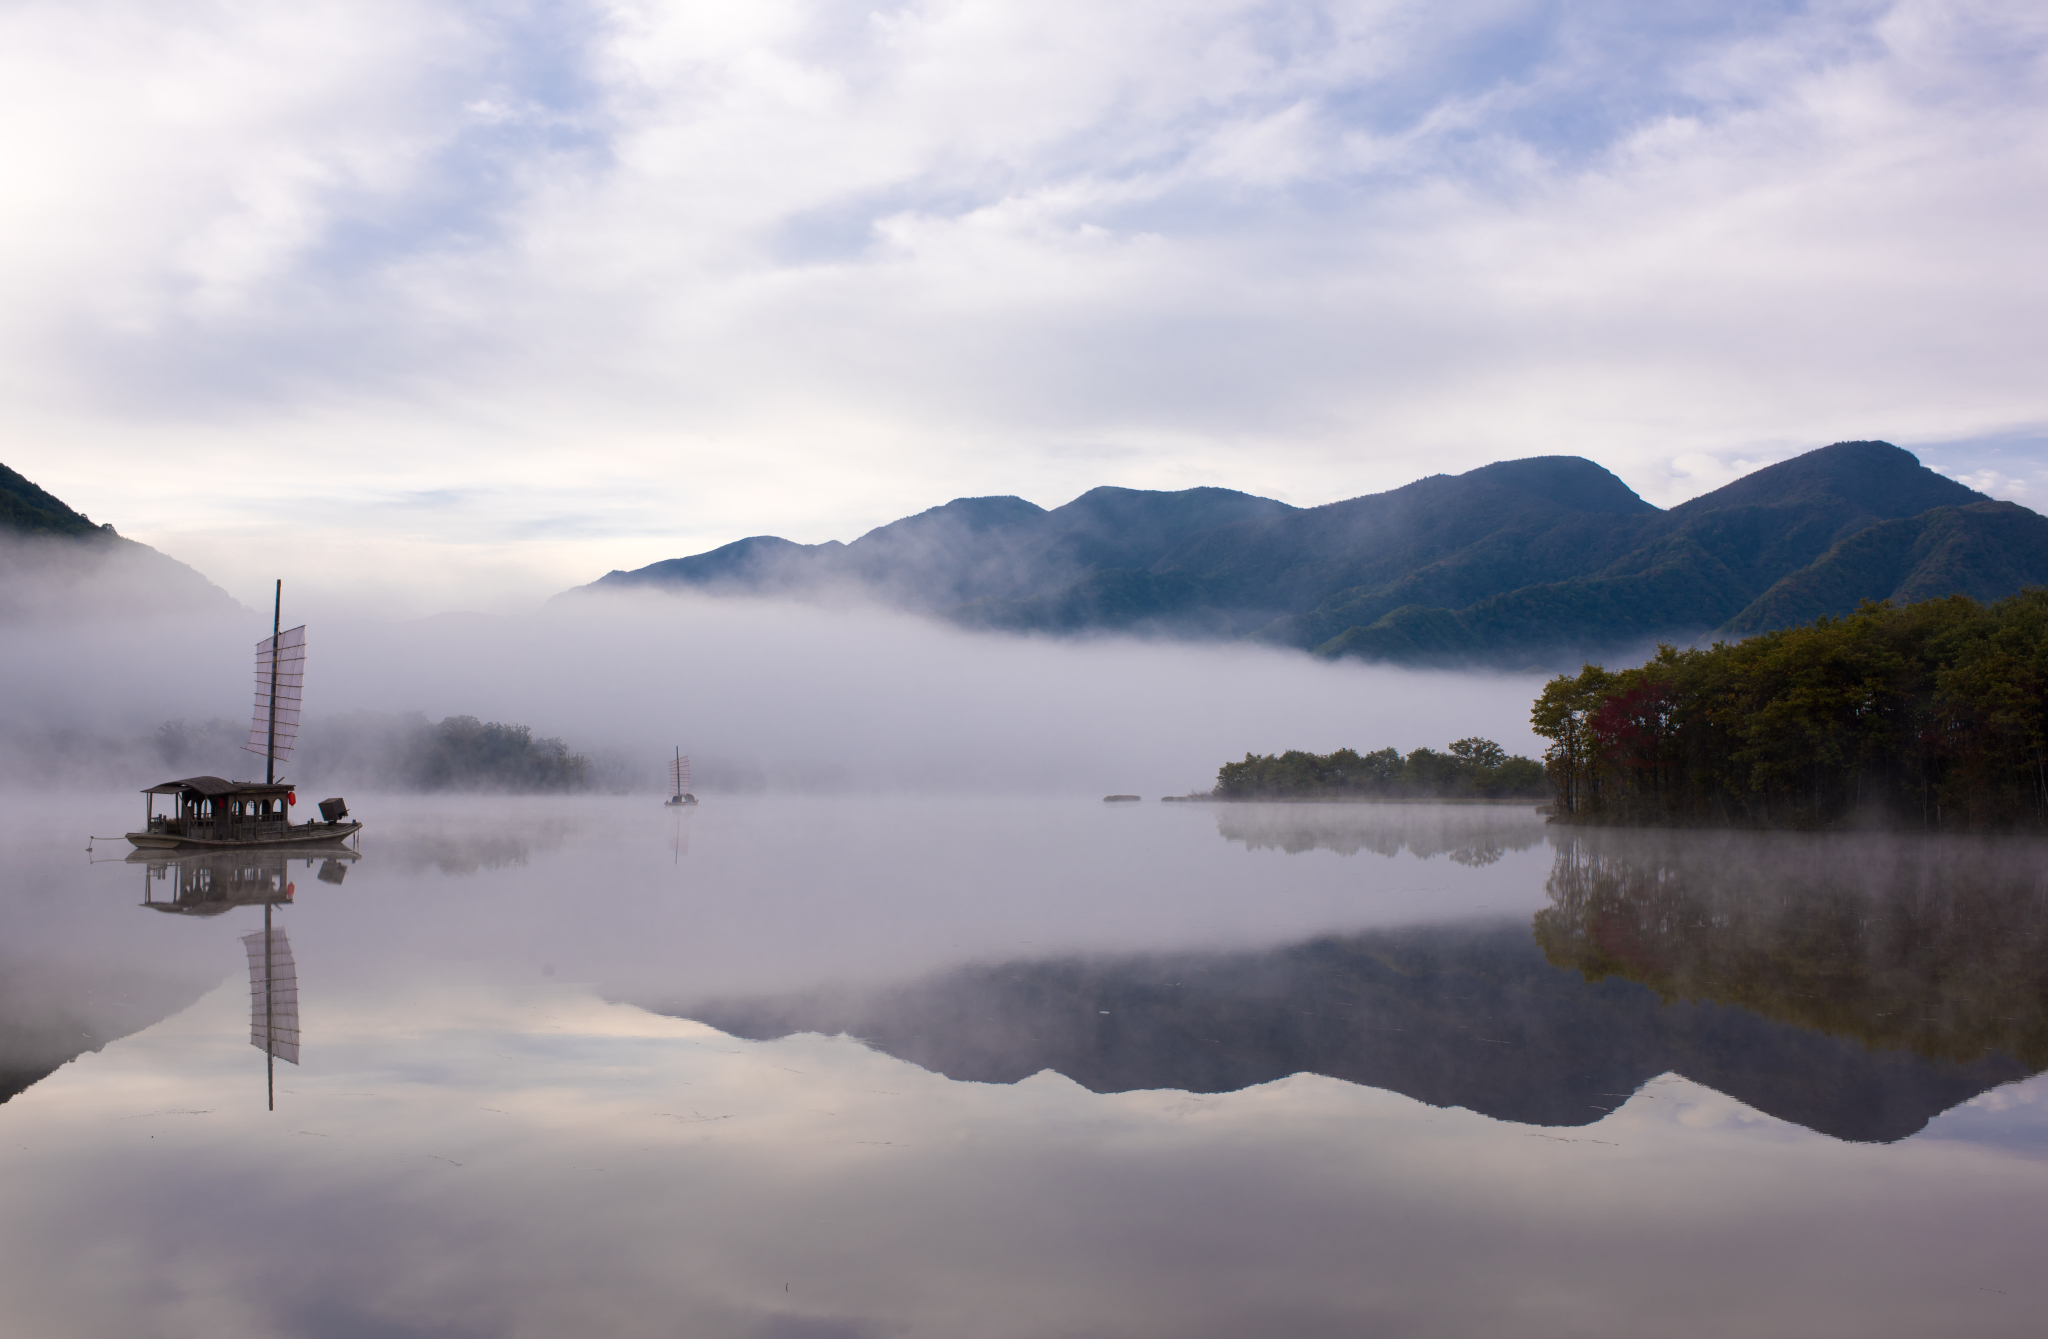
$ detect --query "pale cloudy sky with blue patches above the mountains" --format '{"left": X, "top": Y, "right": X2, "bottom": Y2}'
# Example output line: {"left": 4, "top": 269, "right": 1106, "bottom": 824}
{"left": 0, "top": 0, "right": 2048, "bottom": 616}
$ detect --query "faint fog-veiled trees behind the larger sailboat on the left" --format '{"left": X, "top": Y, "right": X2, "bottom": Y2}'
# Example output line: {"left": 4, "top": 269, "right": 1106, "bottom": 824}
{"left": 154, "top": 712, "right": 596, "bottom": 792}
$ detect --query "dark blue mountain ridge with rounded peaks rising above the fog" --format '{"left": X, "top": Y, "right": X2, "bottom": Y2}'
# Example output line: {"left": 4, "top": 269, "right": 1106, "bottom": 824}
{"left": 580, "top": 442, "right": 2048, "bottom": 663}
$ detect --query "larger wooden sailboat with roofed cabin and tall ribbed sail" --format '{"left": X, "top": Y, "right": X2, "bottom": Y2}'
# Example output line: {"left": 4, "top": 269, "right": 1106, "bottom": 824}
{"left": 127, "top": 581, "right": 362, "bottom": 850}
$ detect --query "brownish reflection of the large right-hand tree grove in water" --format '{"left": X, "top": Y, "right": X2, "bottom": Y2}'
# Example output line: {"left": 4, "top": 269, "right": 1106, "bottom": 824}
{"left": 1536, "top": 831, "right": 2048, "bottom": 1073}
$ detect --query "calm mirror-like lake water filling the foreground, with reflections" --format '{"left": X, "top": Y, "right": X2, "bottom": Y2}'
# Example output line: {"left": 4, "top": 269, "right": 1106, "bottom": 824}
{"left": 0, "top": 794, "right": 2048, "bottom": 1339}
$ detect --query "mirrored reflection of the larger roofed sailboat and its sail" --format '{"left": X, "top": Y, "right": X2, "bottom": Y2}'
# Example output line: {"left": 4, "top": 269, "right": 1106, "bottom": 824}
{"left": 129, "top": 848, "right": 360, "bottom": 1112}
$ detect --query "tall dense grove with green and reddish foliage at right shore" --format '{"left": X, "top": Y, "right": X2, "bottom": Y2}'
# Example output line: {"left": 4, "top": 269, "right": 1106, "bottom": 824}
{"left": 1532, "top": 590, "right": 2048, "bottom": 829}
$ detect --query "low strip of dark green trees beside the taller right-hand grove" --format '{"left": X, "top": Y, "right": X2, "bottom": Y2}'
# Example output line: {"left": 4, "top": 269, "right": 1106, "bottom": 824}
{"left": 1210, "top": 737, "right": 1544, "bottom": 801}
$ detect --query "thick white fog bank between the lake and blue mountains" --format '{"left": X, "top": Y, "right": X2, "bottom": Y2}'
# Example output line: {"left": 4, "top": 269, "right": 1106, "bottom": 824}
{"left": 0, "top": 584, "right": 1542, "bottom": 796}
